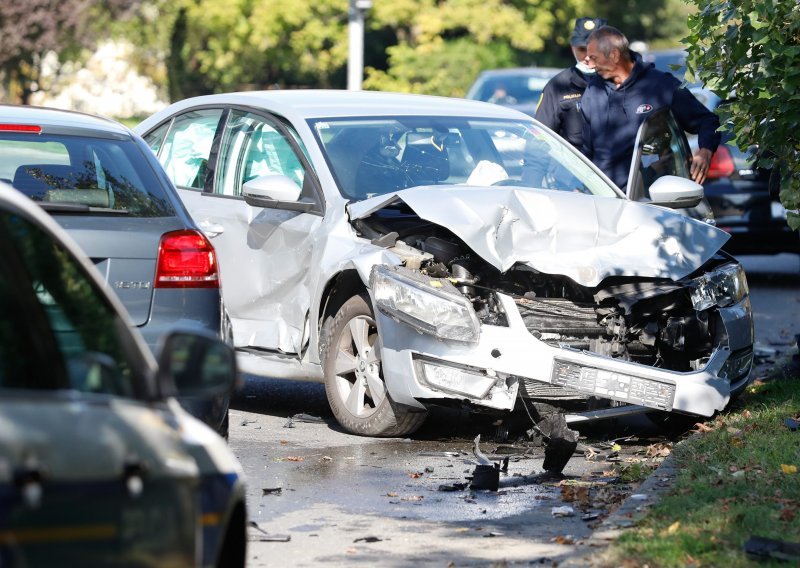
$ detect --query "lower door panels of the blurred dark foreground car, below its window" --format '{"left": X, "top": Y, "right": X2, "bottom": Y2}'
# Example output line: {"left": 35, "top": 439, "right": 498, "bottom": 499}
{"left": 0, "top": 393, "right": 200, "bottom": 566}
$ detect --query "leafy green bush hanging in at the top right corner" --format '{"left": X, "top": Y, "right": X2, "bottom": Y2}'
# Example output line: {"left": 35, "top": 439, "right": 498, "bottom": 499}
{"left": 685, "top": 0, "right": 800, "bottom": 229}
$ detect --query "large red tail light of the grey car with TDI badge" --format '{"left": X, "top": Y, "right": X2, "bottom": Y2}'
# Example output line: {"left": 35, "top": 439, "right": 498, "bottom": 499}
{"left": 155, "top": 229, "right": 219, "bottom": 288}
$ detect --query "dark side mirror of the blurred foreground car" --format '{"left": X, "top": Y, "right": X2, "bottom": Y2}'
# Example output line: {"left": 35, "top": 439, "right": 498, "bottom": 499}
{"left": 158, "top": 331, "right": 237, "bottom": 398}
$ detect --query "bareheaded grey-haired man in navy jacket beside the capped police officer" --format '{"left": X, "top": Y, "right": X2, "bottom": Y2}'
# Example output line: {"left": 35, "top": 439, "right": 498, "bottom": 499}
{"left": 581, "top": 26, "right": 720, "bottom": 190}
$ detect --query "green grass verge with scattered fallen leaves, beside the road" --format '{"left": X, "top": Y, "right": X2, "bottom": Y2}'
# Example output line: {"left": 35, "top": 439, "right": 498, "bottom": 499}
{"left": 602, "top": 368, "right": 800, "bottom": 568}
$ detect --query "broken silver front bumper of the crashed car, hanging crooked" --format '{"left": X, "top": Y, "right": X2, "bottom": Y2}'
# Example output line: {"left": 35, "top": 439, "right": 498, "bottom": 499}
{"left": 376, "top": 294, "right": 753, "bottom": 416}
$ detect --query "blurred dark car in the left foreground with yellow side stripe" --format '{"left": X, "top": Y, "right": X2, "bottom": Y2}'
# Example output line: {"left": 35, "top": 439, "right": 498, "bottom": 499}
{"left": 0, "top": 183, "right": 246, "bottom": 567}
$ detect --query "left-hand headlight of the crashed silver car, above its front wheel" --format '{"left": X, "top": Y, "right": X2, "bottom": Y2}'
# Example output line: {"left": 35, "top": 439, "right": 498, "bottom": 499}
{"left": 370, "top": 266, "right": 480, "bottom": 342}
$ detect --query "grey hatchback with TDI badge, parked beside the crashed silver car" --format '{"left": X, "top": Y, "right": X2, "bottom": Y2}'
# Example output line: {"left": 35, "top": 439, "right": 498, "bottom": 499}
{"left": 0, "top": 105, "right": 229, "bottom": 434}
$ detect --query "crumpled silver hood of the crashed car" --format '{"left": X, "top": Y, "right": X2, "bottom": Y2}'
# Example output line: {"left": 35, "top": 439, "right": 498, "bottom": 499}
{"left": 348, "top": 186, "right": 729, "bottom": 287}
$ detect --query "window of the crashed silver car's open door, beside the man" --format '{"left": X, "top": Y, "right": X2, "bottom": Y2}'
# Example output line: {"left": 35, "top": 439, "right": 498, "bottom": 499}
{"left": 628, "top": 108, "right": 691, "bottom": 201}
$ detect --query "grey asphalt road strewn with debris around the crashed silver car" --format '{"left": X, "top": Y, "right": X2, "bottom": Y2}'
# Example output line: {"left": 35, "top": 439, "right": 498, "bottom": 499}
{"left": 230, "top": 255, "right": 800, "bottom": 567}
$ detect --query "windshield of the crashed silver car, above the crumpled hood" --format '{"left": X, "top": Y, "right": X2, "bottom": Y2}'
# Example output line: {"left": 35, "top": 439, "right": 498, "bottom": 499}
{"left": 311, "top": 116, "right": 618, "bottom": 201}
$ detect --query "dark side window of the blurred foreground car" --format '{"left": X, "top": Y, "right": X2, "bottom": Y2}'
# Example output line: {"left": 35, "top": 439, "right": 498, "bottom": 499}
{"left": 0, "top": 211, "right": 137, "bottom": 397}
